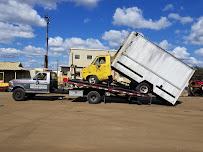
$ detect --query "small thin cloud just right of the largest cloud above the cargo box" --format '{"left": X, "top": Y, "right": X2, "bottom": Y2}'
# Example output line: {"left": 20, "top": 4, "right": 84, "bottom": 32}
{"left": 168, "top": 13, "right": 193, "bottom": 24}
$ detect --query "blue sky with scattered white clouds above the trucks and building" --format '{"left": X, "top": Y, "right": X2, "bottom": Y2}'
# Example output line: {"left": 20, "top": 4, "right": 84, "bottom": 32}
{"left": 0, "top": 0, "right": 203, "bottom": 69}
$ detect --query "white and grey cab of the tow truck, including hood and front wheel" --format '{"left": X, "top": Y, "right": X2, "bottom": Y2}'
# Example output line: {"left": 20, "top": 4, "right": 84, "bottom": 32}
{"left": 9, "top": 72, "right": 58, "bottom": 101}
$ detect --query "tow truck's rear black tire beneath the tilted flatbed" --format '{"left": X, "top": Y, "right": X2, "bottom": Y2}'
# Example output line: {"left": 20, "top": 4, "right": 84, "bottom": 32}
{"left": 87, "top": 91, "right": 101, "bottom": 104}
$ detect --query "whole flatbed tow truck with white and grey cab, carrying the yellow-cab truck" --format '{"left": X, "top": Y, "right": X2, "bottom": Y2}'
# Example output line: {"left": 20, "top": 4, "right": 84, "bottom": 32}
{"left": 9, "top": 71, "right": 152, "bottom": 104}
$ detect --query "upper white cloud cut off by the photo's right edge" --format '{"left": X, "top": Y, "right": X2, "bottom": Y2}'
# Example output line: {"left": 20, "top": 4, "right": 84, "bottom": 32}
{"left": 185, "top": 16, "right": 203, "bottom": 45}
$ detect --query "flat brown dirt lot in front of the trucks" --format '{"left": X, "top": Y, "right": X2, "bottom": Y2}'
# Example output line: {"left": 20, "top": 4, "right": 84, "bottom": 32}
{"left": 0, "top": 93, "right": 203, "bottom": 152}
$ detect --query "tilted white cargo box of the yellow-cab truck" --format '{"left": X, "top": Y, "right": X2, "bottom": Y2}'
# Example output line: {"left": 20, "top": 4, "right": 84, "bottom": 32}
{"left": 112, "top": 32, "right": 195, "bottom": 104}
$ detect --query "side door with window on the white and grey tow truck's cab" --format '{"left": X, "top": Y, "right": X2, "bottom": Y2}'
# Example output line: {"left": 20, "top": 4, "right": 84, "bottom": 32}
{"left": 30, "top": 72, "right": 50, "bottom": 93}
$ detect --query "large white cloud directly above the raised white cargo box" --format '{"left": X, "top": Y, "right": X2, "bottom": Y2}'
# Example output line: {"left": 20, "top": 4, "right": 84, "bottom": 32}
{"left": 113, "top": 7, "right": 171, "bottom": 30}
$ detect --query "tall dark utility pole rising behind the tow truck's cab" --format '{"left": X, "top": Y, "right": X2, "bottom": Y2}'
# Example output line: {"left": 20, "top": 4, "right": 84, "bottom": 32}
{"left": 44, "top": 15, "right": 50, "bottom": 70}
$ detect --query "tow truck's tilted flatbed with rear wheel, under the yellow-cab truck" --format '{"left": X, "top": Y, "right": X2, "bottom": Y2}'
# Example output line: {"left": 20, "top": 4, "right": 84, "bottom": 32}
{"left": 67, "top": 80, "right": 152, "bottom": 104}
